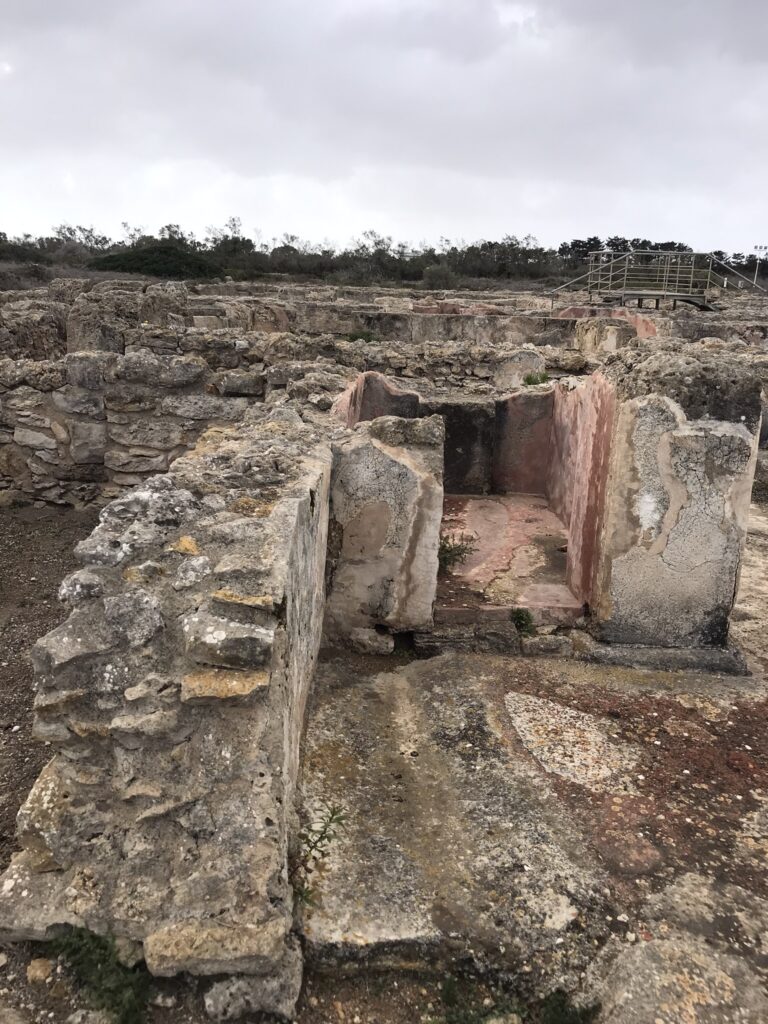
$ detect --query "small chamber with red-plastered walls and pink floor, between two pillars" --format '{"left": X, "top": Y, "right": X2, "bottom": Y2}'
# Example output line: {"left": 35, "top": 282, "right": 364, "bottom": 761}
{"left": 338, "top": 373, "right": 606, "bottom": 627}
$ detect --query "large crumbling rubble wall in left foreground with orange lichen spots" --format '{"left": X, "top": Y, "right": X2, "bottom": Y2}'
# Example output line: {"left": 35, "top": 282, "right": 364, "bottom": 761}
{"left": 0, "top": 411, "right": 331, "bottom": 1014}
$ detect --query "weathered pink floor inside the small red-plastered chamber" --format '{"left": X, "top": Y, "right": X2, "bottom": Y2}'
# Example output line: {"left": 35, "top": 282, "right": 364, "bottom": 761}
{"left": 435, "top": 495, "right": 583, "bottom": 626}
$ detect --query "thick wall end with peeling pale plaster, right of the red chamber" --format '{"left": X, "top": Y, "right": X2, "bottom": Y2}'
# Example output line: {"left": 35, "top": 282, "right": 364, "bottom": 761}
{"left": 592, "top": 346, "right": 761, "bottom": 647}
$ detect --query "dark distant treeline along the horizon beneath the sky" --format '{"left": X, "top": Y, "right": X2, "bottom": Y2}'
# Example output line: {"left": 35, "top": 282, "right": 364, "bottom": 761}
{"left": 0, "top": 217, "right": 756, "bottom": 288}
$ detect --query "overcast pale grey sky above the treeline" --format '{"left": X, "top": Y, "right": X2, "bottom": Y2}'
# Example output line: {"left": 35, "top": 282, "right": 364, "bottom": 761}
{"left": 0, "top": 0, "right": 768, "bottom": 251}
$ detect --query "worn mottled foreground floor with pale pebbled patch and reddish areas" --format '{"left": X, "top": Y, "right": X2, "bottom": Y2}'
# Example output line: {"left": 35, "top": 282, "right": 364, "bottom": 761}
{"left": 303, "top": 507, "right": 768, "bottom": 1024}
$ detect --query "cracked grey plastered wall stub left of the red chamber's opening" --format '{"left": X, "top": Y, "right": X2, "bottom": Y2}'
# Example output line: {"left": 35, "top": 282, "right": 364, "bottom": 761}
{"left": 327, "top": 416, "right": 444, "bottom": 647}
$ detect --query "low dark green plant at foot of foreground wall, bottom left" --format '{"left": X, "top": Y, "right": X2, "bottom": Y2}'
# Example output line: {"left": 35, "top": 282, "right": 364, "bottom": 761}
{"left": 50, "top": 928, "right": 150, "bottom": 1024}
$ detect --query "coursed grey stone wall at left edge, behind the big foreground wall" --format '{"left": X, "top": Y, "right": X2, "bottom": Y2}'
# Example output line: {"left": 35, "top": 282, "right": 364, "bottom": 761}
{"left": 0, "top": 350, "right": 259, "bottom": 503}
